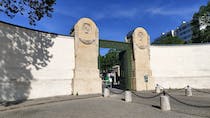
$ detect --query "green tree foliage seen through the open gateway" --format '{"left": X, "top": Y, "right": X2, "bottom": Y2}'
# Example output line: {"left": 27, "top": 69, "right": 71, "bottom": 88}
{"left": 99, "top": 49, "right": 120, "bottom": 72}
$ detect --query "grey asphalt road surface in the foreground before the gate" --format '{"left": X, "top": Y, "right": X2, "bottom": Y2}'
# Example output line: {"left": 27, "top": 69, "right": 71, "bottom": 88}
{"left": 0, "top": 90, "right": 210, "bottom": 118}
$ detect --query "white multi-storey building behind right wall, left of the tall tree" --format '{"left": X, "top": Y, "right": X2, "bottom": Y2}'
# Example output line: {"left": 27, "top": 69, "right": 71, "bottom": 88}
{"left": 175, "top": 21, "right": 193, "bottom": 41}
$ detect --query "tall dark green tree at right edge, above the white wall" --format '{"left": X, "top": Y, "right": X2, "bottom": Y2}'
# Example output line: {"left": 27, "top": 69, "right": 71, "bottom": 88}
{"left": 191, "top": 2, "right": 210, "bottom": 43}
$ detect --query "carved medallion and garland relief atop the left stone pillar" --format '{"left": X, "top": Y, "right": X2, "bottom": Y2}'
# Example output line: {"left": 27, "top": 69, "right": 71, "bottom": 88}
{"left": 79, "top": 23, "right": 95, "bottom": 45}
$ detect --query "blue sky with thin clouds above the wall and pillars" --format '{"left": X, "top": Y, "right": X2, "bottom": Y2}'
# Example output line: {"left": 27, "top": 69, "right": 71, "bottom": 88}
{"left": 0, "top": 0, "right": 208, "bottom": 54}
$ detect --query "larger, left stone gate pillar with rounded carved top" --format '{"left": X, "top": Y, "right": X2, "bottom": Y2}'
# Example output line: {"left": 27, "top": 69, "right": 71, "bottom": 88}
{"left": 71, "top": 18, "right": 102, "bottom": 95}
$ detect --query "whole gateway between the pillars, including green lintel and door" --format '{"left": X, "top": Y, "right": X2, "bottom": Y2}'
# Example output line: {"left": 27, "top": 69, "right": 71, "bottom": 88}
{"left": 99, "top": 40, "right": 133, "bottom": 89}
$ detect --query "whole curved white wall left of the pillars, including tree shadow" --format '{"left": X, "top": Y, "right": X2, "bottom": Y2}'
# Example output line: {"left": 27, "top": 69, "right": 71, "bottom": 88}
{"left": 0, "top": 22, "right": 75, "bottom": 102}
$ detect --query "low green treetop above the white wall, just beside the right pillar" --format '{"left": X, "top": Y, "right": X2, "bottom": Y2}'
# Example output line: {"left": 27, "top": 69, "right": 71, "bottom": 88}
{"left": 152, "top": 36, "right": 185, "bottom": 44}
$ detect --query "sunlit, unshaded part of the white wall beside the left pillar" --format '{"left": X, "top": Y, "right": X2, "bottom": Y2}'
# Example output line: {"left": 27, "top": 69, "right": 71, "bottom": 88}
{"left": 29, "top": 36, "right": 75, "bottom": 98}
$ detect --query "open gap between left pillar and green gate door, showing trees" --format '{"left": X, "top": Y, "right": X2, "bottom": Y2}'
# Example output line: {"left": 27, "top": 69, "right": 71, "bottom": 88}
{"left": 99, "top": 48, "right": 122, "bottom": 88}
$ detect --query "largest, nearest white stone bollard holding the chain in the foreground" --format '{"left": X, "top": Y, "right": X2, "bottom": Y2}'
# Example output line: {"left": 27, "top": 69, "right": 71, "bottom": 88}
{"left": 160, "top": 91, "right": 171, "bottom": 111}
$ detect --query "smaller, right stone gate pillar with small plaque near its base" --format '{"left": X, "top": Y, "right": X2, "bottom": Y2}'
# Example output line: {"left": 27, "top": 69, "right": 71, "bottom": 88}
{"left": 127, "top": 28, "right": 155, "bottom": 91}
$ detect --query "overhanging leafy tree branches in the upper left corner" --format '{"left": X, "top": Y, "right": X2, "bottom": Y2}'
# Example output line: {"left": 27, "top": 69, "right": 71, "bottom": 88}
{"left": 0, "top": 0, "right": 56, "bottom": 25}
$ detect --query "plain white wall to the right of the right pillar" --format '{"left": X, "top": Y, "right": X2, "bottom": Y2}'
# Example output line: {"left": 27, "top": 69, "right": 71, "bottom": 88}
{"left": 150, "top": 44, "right": 210, "bottom": 88}
